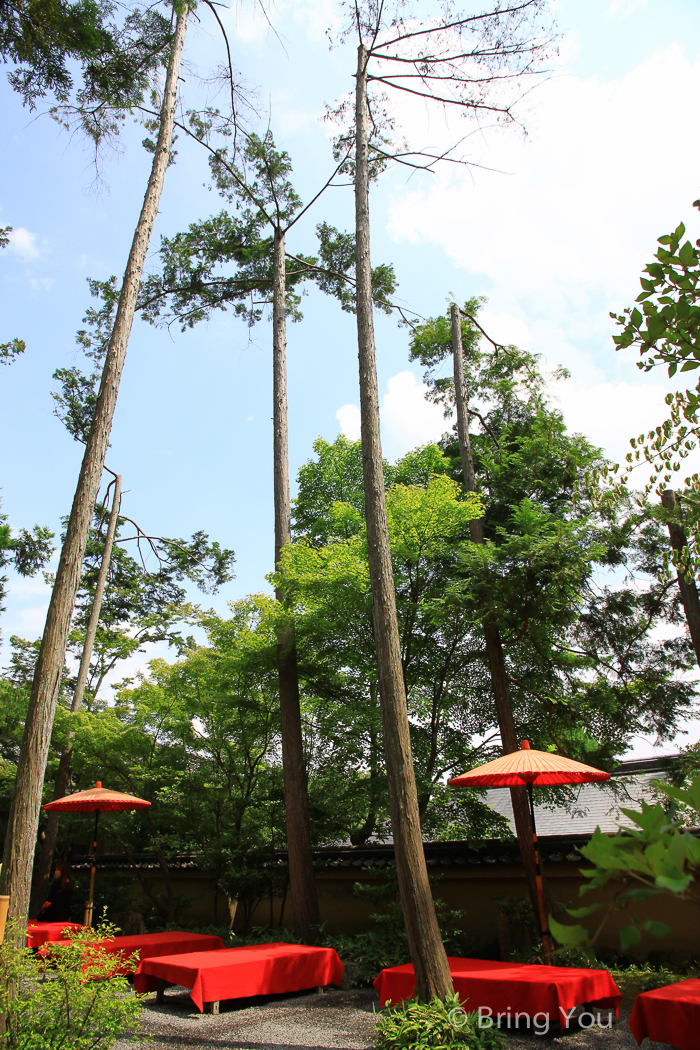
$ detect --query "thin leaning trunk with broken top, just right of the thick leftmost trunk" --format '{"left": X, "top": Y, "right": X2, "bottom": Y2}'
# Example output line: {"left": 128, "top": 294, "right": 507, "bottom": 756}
{"left": 29, "top": 474, "right": 122, "bottom": 919}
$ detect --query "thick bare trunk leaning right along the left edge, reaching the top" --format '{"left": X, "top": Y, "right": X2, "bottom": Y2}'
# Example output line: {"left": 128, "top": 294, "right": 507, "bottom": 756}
{"left": 0, "top": 10, "right": 188, "bottom": 918}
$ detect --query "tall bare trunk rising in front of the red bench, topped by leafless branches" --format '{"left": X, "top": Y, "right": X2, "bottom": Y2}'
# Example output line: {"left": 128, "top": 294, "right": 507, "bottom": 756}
{"left": 355, "top": 44, "right": 452, "bottom": 1000}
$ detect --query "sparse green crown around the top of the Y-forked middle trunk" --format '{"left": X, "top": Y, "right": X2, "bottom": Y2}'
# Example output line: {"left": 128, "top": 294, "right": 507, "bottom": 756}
{"left": 137, "top": 127, "right": 396, "bottom": 331}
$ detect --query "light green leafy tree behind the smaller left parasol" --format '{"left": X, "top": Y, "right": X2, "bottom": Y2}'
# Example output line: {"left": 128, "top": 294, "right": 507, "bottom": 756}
{"left": 55, "top": 596, "right": 284, "bottom": 922}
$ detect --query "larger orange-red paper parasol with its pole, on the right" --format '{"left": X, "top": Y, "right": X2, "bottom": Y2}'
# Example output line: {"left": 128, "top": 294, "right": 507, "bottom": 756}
{"left": 447, "top": 740, "right": 610, "bottom": 964}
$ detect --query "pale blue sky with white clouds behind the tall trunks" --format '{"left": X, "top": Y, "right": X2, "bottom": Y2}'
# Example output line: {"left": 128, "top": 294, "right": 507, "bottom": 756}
{"left": 0, "top": 0, "right": 700, "bottom": 750}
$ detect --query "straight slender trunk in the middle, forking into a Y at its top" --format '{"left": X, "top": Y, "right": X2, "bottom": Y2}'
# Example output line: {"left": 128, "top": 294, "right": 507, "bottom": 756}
{"left": 272, "top": 228, "right": 321, "bottom": 941}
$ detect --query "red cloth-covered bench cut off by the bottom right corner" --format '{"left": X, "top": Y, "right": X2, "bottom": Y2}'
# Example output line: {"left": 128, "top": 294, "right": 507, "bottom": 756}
{"left": 629, "top": 978, "right": 700, "bottom": 1050}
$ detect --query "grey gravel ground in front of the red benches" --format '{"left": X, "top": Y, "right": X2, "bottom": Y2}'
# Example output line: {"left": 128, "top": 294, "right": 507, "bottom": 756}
{"left": 115, "top": 987, "right": 671, "bottom": 1050}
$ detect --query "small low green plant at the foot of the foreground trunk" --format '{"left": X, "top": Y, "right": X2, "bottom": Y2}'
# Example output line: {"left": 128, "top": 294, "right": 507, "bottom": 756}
{"left": 376, "top": 993, "right": 506, "bottom": 1050}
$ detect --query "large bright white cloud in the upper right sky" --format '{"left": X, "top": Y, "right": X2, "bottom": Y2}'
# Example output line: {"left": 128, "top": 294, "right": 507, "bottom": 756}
{"left": 388, "top": 45, "right": 700, "bottom": 366}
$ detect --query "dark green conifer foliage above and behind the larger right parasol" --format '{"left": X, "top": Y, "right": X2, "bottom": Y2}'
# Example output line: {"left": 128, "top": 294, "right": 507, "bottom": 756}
{"left": 411, "top": 299, "right": 695, "bottom": 768}
